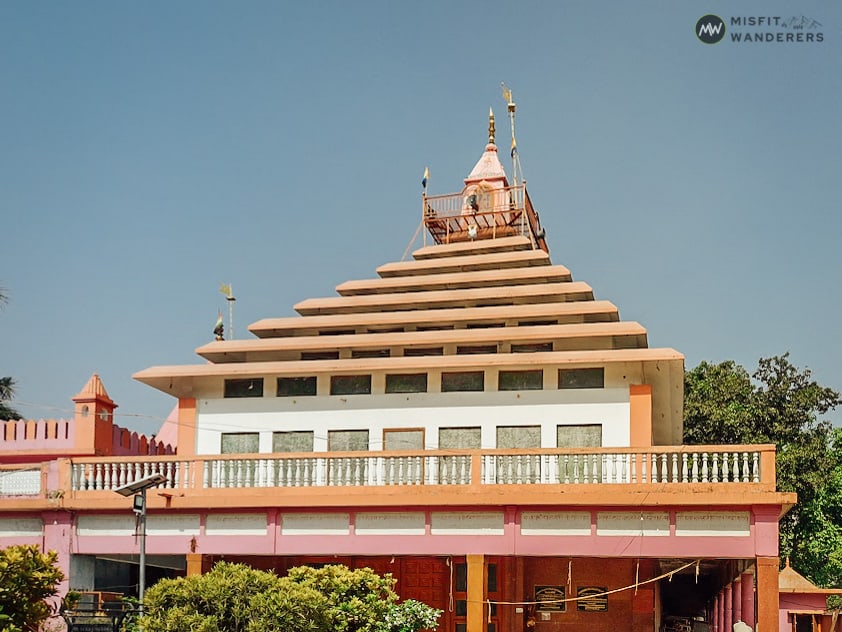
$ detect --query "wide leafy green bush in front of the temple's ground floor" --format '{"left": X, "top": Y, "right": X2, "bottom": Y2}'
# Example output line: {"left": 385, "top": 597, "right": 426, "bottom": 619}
{"left": 139, "top": 562, "right": 441, "bottom": 632}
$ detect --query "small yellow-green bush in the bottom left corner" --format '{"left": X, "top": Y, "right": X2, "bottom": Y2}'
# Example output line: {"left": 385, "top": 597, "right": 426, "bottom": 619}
{"left": 0, "top": 545, "right": 64, "bottom": 632}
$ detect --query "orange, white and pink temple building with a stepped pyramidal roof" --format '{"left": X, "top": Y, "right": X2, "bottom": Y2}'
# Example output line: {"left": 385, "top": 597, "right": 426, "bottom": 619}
{"left": 0, "top": 108, "right": 812, "bottom": 632}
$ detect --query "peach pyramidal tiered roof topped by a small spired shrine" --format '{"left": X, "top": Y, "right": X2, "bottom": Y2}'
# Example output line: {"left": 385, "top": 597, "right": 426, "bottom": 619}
{"left": 135, "top": 120, "right": 683, "bottom": 424}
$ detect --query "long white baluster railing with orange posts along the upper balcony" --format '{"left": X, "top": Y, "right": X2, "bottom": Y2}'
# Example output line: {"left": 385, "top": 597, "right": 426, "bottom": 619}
{"left": 64, "top": 445, "right": 775, "bottom": 492}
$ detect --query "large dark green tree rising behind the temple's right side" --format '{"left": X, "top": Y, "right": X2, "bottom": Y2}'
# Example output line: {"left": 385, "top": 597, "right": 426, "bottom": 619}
{"left": 684, "top": 353, "right": 842, "bottom": 585}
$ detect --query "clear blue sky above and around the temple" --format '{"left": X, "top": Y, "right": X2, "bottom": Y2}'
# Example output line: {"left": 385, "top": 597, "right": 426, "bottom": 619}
{"left": 0, "top": 0, "right": 842, "bottom": 432}
